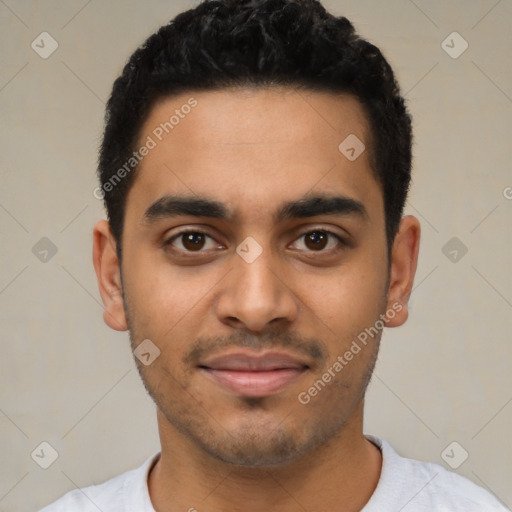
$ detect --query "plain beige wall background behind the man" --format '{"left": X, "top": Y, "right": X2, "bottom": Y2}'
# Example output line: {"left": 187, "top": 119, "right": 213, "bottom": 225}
{"left": 0, "top": 0, "right": 512, "bottom": 512}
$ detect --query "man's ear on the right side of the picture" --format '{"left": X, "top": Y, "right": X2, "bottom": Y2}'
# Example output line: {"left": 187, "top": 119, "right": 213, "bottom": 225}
{"left": 385, "top": 215, "right": 421, "bottom": 327}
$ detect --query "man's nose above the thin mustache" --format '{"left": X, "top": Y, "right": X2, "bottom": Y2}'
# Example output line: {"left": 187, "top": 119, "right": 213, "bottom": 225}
{"left": 215, "top": 245, "right": 299, "bottom": 332}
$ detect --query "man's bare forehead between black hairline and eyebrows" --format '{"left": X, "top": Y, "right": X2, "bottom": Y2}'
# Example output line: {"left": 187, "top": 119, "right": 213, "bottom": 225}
{"left": 126, "top": 87, "right": 382, "bottom": 227}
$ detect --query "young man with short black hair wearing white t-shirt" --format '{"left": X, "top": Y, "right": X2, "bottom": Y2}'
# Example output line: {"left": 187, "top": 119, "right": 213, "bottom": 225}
{"left": 43, "top": 0, "right": 505, "bottom": 512}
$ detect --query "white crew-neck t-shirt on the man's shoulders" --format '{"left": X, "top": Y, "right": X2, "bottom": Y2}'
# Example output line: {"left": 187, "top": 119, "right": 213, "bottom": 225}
{"left": 39, "top": 435, "right": 510, "bottom": 512}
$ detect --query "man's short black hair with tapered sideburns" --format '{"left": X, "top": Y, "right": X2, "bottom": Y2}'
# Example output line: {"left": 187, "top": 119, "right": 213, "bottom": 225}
{"left": 95, "top": 0, "right": 412, "bottom": 263}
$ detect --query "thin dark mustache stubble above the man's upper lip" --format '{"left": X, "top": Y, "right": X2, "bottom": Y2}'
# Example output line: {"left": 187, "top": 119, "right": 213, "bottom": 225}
{"left": 183, "top": 330, "right": 328, "bottom": 366}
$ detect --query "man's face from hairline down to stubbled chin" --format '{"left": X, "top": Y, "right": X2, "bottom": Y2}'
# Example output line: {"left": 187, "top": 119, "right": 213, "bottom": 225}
{"left": 95, "top": 88, "right": 412, "bottom": 466}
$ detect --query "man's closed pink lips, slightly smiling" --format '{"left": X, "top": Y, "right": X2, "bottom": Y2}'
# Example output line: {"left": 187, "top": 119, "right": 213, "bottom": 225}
{"left": 198, "top": 352, "right": 309, "bottom": 397}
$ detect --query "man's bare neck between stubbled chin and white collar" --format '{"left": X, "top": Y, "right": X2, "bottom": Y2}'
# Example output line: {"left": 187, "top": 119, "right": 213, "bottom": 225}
{"left": 148, "top": 402, "right": 382, "bottom": 512}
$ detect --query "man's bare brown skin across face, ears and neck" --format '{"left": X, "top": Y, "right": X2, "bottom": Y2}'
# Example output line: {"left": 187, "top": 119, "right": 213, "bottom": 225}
{"left": 93, "top": 87, "right": 420, "bottom": 512}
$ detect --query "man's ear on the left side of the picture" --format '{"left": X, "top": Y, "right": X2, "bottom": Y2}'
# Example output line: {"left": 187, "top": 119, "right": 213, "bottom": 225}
{"left": 93, "top": 220, "right": 128, "bottom": 331}
